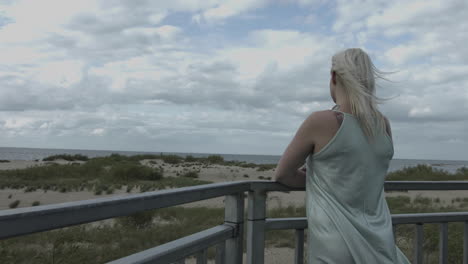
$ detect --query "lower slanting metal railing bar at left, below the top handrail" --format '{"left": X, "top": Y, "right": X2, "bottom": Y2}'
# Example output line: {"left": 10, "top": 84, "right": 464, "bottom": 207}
{"left": 107, "top": 225, "right": 232, "bottom": 264}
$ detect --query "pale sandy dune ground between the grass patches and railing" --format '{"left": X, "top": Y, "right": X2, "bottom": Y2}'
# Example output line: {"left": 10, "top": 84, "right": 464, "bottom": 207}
{"left": 0, "top": 160, "right": 468, "bottom": 210}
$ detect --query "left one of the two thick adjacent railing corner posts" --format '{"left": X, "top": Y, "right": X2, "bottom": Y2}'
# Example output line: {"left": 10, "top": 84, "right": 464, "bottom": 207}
{"left": 224, "top": 192, "right": 244, "bottom": 264}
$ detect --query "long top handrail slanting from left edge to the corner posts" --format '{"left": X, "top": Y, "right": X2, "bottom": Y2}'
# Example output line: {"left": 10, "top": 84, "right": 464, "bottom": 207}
{"left": 0, "top": 181, "right": 250, "bottom": 239}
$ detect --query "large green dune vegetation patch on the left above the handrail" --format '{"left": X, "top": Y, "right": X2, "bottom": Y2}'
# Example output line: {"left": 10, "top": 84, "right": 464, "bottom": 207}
{"left": 0, "top": 154, "right": 210, "bottom": 194}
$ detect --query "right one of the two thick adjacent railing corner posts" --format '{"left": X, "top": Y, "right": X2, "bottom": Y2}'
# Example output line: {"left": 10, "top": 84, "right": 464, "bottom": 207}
{"left": 247, "top": 190, "right": 266, "bottom": 264}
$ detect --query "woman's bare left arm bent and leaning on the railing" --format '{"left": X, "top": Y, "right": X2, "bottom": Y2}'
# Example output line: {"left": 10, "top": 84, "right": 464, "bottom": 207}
{"left": 275, "top": 113, "right": 318, "bottom": 188}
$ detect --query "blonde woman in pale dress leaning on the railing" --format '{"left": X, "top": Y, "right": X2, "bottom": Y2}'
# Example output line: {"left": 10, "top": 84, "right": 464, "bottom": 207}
{"left": 275, "top": 48, "right": 410, "bottom": 264}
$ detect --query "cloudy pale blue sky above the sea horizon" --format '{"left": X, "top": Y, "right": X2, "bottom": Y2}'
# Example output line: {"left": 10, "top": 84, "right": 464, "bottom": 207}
{"left": 0, "top": 0, "right": 468, "bottom": 160}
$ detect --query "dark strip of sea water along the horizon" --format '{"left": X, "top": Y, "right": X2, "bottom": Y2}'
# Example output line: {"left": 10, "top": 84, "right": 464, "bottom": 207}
{"left": 0, "top": 147, "right": 468, "bottom": 173}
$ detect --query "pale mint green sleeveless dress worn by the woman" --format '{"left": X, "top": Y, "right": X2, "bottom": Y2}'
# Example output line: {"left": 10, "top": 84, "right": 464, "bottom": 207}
{"left": 306, "top": 110, "right": 410, "bottom": 264}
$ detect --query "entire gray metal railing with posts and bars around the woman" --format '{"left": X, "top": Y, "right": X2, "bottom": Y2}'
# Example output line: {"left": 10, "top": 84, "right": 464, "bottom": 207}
{"left": 0, "top": 181, "right": 468, "bottom": 264}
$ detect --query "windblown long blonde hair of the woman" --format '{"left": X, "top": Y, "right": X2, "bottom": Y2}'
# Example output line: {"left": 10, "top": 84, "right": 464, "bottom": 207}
{"left": 332, "top": 48, "right": 394, "bottom": 141}
